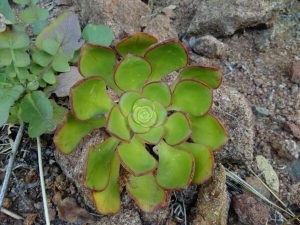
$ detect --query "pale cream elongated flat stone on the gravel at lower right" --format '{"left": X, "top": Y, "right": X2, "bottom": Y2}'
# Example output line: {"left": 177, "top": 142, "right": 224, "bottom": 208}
{"left": 256, "top": 155, "right": 279, "bottom": 192}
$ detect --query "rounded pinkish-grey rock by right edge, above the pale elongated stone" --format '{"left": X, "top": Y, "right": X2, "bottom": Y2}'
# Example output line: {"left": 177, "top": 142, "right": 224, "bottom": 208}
{"left": 271, "top": 140, "right": 300, "bottom": 160}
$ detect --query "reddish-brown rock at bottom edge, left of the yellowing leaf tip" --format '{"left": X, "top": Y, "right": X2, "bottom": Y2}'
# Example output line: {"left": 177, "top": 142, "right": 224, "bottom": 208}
{"left": 57, "top": 197, "right": 93, "bottom": 224}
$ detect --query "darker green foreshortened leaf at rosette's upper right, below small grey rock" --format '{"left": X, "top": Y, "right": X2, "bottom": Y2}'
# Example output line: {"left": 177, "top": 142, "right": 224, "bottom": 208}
{"left": 178, "top": 66, "right": 222, "bottom": 89}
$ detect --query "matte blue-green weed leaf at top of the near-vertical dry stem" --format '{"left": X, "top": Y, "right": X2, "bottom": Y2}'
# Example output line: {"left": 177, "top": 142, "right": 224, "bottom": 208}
{"left": 20, "top": 91, "right": 55, "bottom": 137}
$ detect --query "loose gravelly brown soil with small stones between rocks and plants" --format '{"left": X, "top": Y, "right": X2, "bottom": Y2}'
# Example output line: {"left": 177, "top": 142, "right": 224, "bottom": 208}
{"left": 0, "top": 1, "right": 300, "bottom": 225}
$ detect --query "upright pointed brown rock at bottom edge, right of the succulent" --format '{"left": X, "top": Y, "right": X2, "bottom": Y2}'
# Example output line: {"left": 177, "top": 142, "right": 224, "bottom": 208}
{"left": 193, "top": 164, "right": 230, "bottom": 225}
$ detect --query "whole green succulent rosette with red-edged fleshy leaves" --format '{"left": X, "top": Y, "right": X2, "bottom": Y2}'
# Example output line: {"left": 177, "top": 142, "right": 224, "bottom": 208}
{"left": 54, "top": 33, "right": 228, "bottom": 214}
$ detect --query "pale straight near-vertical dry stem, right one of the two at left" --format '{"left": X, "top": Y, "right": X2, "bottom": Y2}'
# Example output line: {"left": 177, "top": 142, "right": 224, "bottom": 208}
{"left": 36, "top": 137, "right": 50, "bottom": 225}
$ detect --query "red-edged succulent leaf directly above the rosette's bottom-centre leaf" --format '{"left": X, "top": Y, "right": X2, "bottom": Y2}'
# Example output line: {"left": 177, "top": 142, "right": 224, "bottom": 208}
{"left": 117, "top": 136, "right": 157, "bottom": 176}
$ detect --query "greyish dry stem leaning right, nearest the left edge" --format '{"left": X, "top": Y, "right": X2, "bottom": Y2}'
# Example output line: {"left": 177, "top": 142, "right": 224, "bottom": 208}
{"left": 0, "top": 123, "right": 24, "bottom": 207}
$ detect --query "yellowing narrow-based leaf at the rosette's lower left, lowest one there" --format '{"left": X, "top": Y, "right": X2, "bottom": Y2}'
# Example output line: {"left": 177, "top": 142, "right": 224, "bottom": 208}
{"left": 93, "top": 154, "right": 121, "bottom": 214}
